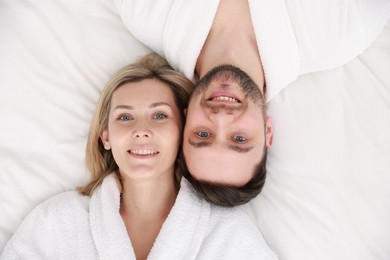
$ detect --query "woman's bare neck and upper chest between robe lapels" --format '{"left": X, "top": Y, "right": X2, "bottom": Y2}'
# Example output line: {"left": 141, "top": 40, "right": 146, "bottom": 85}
{"left": 120, "top": 173, "right": 178, "bottom": 259}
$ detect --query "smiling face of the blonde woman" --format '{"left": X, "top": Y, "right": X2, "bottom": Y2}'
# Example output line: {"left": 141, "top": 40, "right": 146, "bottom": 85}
{"left": 101, "top": 79, "right": 182, "bottom": 182}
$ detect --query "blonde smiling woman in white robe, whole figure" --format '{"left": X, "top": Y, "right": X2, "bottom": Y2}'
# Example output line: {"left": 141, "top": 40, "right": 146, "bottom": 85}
{"left": 1, "top": 54, "right": 276, "bottom": 259}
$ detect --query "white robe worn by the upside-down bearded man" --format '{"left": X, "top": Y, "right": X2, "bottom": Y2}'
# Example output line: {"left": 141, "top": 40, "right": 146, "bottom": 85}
{"left": 116, "top": 0, "right": 390, "bottom": 101}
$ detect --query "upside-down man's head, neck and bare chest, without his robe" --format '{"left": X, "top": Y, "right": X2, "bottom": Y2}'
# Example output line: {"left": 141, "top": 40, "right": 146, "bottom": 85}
{"left": 179, "top": 1, "right": 272, "bottom": 206}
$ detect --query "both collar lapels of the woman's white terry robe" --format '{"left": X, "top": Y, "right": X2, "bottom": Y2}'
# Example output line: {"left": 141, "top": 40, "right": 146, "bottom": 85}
{"left": 90, "top": 174, "right": 210, "bottom": 259}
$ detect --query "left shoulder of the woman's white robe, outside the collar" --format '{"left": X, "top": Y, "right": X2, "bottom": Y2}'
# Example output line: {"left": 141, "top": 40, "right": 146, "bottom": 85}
{"left": 0, "top": 191, "right": 95, "bottom": 259}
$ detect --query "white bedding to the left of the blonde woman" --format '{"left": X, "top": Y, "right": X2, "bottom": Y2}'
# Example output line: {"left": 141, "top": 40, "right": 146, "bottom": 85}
{"left": 0, "top": 0, "right": 148, "bottom": 250}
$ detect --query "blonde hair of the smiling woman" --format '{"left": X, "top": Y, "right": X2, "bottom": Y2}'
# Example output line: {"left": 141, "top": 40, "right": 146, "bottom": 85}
{"left": 78, "top": 53, "right": 194, "bottom": 196}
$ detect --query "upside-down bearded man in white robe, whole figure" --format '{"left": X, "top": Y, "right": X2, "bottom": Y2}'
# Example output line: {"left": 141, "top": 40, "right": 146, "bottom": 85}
{"left": 116, "top": 0, "right": 390, "bottom": 206}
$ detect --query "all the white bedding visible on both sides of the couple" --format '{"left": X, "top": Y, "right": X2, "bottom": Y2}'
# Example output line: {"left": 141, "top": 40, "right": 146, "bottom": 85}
{"left": 0, "top": 0, "right": 390, "bottom": 259}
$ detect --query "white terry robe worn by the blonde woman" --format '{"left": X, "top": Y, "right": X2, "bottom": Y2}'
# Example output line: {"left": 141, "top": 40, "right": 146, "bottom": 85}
{"left": 0, "top": 175, "right": 277, "bottom": 260}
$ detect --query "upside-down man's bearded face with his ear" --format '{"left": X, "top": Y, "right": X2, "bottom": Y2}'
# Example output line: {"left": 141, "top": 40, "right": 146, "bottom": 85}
{"left": 183, "top": 66, "right": 272, "bottom": 186}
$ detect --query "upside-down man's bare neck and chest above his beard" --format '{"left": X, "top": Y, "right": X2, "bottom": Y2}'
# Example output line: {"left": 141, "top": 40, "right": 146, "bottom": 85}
{"left": 196, "top": 0, "right": 264, "bottom": 92}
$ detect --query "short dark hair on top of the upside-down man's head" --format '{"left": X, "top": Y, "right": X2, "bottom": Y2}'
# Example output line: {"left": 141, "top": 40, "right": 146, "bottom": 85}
{"left": 180, "top": 149, "right": 267, "bottom": 207}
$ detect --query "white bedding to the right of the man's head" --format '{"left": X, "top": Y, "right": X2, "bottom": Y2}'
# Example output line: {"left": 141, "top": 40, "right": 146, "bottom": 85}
{"left": 246, "top": 22, "right": 390, "bottom": 260}
